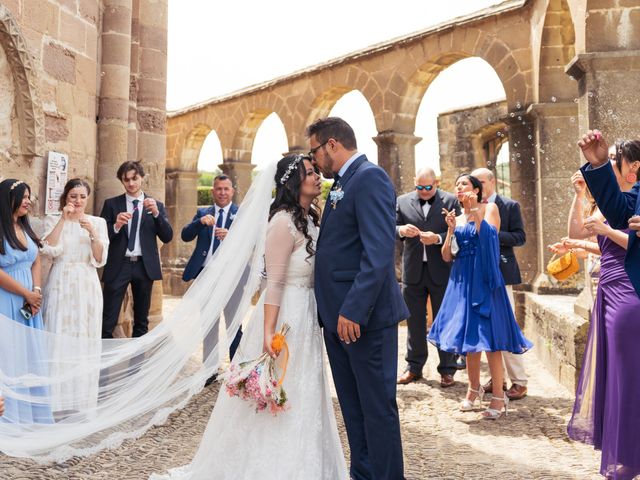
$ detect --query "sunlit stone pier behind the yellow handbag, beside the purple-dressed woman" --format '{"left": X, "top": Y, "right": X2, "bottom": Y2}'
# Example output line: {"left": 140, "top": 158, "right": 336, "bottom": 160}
{"left": 528, "top": 102, "right": 583, "bottom": 293}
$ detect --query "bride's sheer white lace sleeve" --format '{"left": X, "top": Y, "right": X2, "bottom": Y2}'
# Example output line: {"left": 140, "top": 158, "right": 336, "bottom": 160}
{"left": 264, "top": 212, "right": 296, "bottom": 306}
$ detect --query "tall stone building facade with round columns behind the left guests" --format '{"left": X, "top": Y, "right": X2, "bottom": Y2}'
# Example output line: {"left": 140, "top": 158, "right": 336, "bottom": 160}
{"left": 0, "top": 0, "right": 168, "bottom": 330}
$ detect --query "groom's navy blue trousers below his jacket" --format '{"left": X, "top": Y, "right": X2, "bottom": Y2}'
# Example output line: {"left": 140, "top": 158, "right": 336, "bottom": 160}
{"left": 324, "top": 325, "right": 404, "bottom": 480}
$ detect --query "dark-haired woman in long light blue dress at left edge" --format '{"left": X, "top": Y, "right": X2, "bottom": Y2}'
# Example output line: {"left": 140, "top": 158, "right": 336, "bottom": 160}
{"left": 0, "top": 179, "right": 53, "bottom": 423}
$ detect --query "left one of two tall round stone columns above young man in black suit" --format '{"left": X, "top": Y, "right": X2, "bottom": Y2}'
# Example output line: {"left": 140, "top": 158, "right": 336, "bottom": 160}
{"left": 94, "top": 0, "right": 131, "bottom": 212}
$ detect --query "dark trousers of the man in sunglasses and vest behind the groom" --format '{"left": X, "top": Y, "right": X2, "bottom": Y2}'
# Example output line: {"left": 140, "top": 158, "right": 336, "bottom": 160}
{"left": 402, "top": 262, "right": 457, "bottom": 375}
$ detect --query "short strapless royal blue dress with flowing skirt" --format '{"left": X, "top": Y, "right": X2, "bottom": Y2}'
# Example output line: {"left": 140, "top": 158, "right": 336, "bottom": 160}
{"left": 427, "top": 220, "right": 533, "bottom": 354}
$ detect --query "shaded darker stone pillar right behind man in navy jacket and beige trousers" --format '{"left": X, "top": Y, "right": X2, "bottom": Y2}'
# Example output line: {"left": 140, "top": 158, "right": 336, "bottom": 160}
{"left": 503, "top": 111, "right": 542, "bottom": 284}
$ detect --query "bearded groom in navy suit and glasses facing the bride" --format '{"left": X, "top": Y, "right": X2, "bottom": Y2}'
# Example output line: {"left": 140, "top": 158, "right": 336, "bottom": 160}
{"left": 307, "top": 117, "right": 409, "bottom": 480}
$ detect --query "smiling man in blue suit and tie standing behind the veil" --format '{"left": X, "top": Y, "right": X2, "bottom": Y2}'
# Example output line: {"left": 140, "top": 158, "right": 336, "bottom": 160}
{"left": 181, "top": 175, "right": 242, "bottom": 385}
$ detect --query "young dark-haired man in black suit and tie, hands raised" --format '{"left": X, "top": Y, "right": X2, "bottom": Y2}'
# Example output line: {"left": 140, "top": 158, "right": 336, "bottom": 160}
{"left": 100, "top": 161, "right": 173, "bottom": 338}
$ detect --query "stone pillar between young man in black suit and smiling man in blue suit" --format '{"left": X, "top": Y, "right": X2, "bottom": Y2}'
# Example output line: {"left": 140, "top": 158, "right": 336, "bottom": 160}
{"left": 162, "top": 170, "right": 199, "bottom": 295}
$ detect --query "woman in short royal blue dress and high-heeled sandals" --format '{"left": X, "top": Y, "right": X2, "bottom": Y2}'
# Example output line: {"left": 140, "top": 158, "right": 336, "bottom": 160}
{"left": 427, "top": 174, "right": 532, "bottom": 419}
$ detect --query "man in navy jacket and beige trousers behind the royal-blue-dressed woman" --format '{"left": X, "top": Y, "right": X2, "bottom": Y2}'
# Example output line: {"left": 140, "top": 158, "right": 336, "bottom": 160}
{"left": 471, "top": 168, "right": 529, "bottom": 400}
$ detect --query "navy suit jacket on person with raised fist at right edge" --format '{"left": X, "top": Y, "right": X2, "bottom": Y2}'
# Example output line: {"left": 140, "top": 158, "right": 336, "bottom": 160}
{"left": 580, "top": 163, "right": 640, "bottom": 297}
